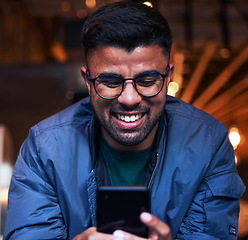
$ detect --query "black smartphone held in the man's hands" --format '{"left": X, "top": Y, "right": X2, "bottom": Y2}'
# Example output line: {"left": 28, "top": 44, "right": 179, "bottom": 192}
{"left": 96, "top": 186, "right": 151, "bottom": 238}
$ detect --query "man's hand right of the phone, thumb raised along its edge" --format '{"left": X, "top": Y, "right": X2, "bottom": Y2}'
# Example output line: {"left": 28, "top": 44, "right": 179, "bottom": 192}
{"left": 113, "top": 213, "right": 173, "bottom": 240}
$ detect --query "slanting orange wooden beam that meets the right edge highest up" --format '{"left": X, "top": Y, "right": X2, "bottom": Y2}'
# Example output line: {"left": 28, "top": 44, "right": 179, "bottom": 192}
{"left": 193, "top": 44, "right": 248, "bottom": 108}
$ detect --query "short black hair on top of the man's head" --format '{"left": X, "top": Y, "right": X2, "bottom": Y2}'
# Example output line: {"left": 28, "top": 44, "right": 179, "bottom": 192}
{"left": 81, "top": 2, "right": 172, "bottom": 56}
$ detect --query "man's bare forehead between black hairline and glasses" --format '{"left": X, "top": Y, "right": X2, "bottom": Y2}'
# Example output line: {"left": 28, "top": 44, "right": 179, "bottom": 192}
{"left": 87, "top": 45, "right": 169, "bottom": 75}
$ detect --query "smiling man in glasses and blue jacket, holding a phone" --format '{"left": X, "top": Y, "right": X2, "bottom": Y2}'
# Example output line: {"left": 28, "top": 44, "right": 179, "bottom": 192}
{"left": 4, "top": 2, "right": 244, "bottom": 240}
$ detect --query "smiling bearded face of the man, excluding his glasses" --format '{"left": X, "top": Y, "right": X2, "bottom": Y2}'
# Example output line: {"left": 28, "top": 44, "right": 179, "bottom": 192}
{"left": 81, "top": 45, "right": 172, "bottom": 151}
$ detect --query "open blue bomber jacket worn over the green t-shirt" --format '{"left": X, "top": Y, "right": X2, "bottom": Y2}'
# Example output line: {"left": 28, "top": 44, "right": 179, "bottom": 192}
{"left": 4, "top": 97, "right": 245, "bottom": 240}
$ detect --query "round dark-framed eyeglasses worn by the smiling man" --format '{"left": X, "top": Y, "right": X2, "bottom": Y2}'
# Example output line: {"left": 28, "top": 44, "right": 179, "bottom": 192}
{"left": 86, "top": 65, "right": 170, "bottom": 99}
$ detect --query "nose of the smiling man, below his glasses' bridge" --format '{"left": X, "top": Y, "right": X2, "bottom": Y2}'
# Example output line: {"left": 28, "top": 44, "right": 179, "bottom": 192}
{"left": 118, "top": 80, "right": 142, "bottom": 106}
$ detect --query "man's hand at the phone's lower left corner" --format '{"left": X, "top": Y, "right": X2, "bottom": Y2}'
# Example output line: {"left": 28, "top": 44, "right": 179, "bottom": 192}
{"left": 72, "top": 227, "right": 115, "bottom": 240}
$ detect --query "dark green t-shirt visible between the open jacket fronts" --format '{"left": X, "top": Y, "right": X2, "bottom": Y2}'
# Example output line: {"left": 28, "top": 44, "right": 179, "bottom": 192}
{"left": 100, "top": 135, "right": 152, "bottom": 186}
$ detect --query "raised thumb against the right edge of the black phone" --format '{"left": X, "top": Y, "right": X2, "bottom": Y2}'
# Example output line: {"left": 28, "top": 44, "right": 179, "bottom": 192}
{"left": 140, "top": 212, "right": 172, "bottom": 240}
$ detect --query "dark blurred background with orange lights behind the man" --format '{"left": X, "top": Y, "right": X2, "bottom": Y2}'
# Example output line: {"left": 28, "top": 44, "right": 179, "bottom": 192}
{"left": 0, "top": 0, "right": 248, "bottom": 239}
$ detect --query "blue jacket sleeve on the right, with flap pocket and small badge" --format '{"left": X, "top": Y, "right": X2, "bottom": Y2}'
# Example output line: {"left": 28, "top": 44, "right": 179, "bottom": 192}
{"left": 176, "top": 122, "right": 245, "bottom": 240}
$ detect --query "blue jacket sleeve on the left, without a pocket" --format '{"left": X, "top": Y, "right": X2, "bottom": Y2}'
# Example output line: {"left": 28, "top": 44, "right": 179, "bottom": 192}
{"left": 3, "top": 130, "right": 67, "bottom": 240}
